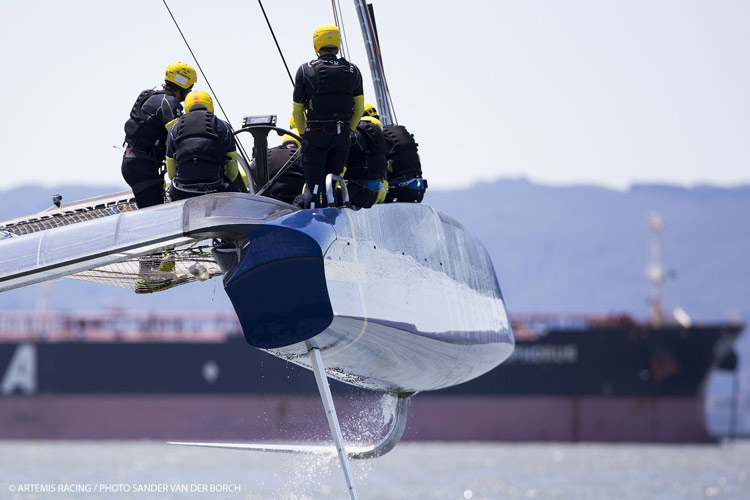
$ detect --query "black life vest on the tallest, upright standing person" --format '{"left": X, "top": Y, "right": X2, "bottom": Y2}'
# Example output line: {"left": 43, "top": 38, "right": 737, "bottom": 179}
{"left": 307, "top": 58, "right": 356, "bottom": 121}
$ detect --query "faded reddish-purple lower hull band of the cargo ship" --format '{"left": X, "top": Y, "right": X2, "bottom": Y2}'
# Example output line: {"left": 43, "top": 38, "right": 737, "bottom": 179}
{"left": 0, "top": 394, "right": 716, "bottom": 443}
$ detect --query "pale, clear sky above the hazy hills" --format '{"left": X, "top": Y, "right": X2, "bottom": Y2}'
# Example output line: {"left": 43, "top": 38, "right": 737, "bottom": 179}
{"left": 0, "top": 0, "right": 750, "bottom": 191}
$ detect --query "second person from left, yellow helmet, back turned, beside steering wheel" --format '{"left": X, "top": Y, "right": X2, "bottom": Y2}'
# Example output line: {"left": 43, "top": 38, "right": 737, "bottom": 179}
{"left": 167, "top": 90, "right": 239, "bottom": 201}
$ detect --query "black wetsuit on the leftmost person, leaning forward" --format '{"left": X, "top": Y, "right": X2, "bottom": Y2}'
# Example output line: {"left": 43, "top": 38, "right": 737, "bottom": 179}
{"left": 120, "top": 90, "right": 182, "bottom": 208}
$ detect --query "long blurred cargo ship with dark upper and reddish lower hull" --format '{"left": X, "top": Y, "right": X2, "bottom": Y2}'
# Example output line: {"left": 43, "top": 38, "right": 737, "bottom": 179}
{"left": 0, "top": 311, "right": 742, "bottom": 443}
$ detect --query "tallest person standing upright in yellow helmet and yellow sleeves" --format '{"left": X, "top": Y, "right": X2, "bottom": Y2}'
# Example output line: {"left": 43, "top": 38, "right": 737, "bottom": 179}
{"left": 292, "top": 24, "right": 365, "bottom": 207}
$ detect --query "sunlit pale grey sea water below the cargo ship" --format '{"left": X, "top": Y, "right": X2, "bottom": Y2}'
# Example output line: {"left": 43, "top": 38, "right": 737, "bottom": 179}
{"left": 0, "top": 441, "right": 750, "bottom": 500}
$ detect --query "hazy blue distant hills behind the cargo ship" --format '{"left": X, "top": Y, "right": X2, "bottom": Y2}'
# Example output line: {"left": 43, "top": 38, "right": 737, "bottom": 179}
{"left": 0, "top": 179, "right": 750, "bottom": 321}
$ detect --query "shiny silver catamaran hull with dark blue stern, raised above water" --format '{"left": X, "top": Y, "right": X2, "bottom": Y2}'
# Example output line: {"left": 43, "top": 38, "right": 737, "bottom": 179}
{"left": 225, "top": 204, "right": 514, "bottom": 393}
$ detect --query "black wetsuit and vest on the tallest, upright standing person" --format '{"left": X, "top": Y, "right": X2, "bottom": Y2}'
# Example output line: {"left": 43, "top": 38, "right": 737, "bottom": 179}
{"left": 293, "top": 54, "right": 363, "bottom": 204}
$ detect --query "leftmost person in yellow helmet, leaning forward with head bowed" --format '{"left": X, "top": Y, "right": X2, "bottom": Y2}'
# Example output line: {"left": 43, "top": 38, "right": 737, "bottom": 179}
{"left": 121, "top": 62, "right": 197, "bottom": 208}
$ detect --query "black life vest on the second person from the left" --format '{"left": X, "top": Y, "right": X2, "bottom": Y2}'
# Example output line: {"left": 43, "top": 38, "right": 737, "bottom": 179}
{"left": 174, "top": 109, "right": 226, "bottom": 183}
